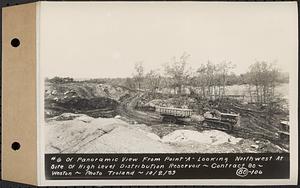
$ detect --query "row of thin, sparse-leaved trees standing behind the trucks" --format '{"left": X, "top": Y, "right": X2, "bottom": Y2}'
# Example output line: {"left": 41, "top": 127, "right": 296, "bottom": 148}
{"left": 129, "top": 53, "right": 289, "bottom": 104}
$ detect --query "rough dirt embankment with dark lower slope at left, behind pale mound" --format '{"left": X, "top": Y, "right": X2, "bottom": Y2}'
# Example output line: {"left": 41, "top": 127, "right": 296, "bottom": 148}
{"left": 45, "top": 82, "right": 130, "bottom": 118}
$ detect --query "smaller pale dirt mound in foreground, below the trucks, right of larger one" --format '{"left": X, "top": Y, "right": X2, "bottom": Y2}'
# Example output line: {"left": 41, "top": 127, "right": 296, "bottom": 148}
{"left": 162, "top": 130, "right": 286, "bottom": 153}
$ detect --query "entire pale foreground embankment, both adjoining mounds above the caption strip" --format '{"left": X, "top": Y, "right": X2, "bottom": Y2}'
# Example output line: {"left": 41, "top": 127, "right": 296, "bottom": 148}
{"left": 45, "top": 113, "right": 280, "bottom": 153}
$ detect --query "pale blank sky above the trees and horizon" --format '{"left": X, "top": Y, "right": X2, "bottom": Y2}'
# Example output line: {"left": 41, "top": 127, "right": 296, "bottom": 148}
{"left": 38, "top": 2, "right": 298, "bottom": 78}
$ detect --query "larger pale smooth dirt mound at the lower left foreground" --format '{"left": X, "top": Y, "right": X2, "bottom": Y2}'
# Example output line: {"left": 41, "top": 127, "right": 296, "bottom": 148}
{"left": 45, "top": 114, "right": 175, "bottom": 153}
